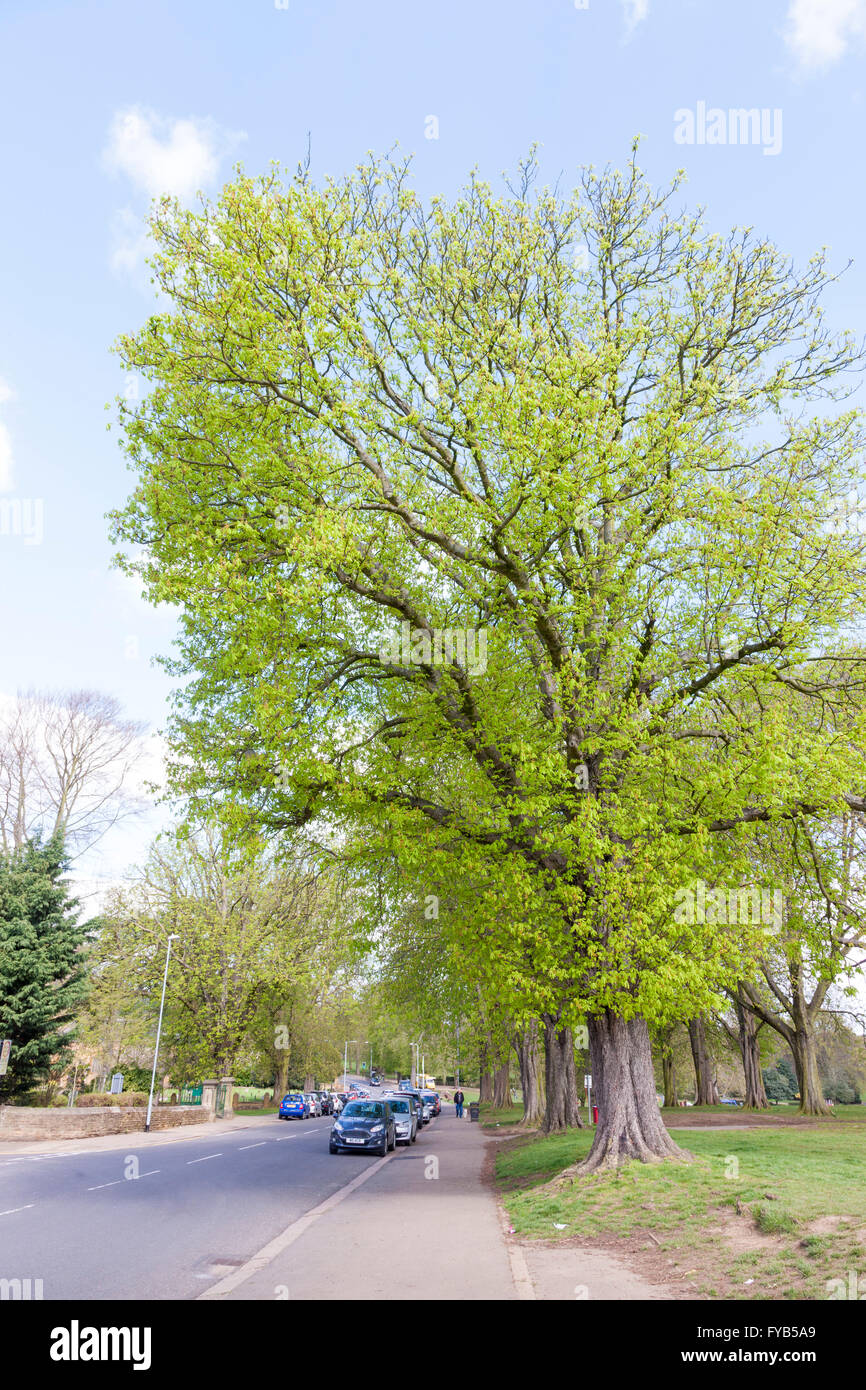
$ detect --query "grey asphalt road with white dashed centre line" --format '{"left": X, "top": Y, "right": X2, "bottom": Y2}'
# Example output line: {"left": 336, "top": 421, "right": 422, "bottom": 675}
{"left": 0, "top": 1116, "right": 343, "bottom": 1298}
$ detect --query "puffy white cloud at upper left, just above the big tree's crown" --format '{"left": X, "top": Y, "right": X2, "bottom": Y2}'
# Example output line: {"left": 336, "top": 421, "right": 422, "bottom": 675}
{"left": 103, "top": 106, "right": 245, "bottom": 199}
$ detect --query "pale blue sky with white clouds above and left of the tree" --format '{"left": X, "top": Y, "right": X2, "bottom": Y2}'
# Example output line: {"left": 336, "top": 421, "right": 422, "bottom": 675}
{"left": 0, "top": 0, "right": 866, "bottom": 884}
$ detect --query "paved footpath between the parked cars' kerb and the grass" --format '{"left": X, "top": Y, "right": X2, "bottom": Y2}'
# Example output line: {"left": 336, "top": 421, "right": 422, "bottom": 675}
{"left": 202, "top": 1105, "right": 532, "bottom": 1301}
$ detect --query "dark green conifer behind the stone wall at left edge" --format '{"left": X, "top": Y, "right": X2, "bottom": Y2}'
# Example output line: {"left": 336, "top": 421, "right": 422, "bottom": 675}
{"left": 0, "top": 835, "right": 86, "bottom": 1097}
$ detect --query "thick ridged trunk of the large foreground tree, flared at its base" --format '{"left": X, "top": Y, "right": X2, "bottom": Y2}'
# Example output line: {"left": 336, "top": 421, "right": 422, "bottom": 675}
{"left": 563, "top": 1009, "right": 691, "bottom": 1176}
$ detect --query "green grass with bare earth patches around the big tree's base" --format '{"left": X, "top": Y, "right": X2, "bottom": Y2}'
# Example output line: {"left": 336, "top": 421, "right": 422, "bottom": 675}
{"left": 496, "top": 1106, "right": 866, "bottom": 1298}
